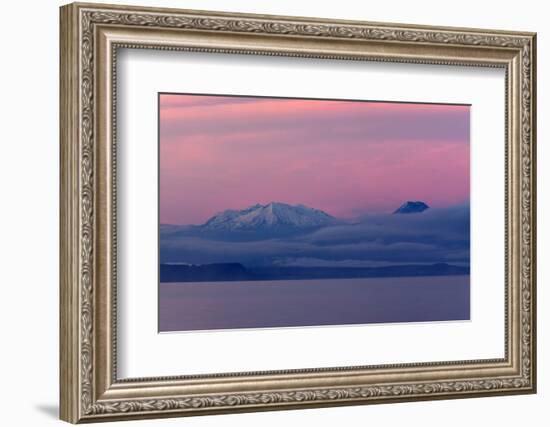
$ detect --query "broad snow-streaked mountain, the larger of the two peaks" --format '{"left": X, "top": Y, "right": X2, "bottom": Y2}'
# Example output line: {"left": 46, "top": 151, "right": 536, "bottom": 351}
{"left": 200, "top": 202, "right": 336, "bottom": 231}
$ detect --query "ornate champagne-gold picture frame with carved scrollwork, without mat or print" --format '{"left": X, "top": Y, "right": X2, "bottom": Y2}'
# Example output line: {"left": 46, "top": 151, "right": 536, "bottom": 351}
{"left": 60, "top": 4, "right": 536, "bottom": 423}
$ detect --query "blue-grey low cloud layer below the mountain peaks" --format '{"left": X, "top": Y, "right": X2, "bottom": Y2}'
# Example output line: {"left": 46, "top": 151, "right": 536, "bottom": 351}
{"left": 160, "top": 205, "right": 470, "bottom": 267}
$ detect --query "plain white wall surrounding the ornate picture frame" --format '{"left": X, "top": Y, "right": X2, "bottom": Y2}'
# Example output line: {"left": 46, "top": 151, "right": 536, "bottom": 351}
{"left": 0, "top": 0, "right": 550, "bottom": 427}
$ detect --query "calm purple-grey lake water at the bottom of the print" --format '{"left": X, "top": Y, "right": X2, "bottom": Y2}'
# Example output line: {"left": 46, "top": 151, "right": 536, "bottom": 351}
{"left": 159, "top": 276, "right": 470, "bottom": 332}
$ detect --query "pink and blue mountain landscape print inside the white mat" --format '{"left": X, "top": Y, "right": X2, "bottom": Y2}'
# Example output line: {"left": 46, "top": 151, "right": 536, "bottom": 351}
{"left": 158, "top": 93, "right": 470, "bottom": 332}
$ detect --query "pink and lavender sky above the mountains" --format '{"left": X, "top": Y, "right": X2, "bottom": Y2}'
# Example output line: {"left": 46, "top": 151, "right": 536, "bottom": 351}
{"left": 160, "top": 94, "right": 470, "bottom": 224}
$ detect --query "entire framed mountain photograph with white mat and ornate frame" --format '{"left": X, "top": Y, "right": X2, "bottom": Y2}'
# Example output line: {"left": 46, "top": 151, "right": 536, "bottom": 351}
{"left": 60, "top": 3, "right": 536, "bottom": 423}
